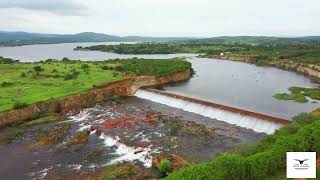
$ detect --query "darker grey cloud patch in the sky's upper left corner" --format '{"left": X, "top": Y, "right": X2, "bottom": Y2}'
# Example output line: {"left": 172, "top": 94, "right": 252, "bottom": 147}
{"left": 0, "top": 0, "right": 88, "bottom": 16}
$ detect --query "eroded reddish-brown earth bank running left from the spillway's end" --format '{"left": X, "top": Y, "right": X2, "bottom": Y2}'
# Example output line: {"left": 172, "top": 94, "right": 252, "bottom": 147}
{"left": 0, "top": 70, "right": 191, "bottom": 126}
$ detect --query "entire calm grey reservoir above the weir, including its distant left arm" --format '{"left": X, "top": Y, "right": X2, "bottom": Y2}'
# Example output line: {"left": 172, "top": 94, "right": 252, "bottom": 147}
{"left": 0, "top": 42, "right": 319, "bottom": 118}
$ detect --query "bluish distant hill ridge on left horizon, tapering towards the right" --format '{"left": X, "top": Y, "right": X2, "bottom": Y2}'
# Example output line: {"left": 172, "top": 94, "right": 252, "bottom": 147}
{"left": 0, "top": 31, "right": 194, "bottom": 46}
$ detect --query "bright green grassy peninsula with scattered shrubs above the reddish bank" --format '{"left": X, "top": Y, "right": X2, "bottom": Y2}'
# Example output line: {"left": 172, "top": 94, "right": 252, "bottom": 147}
{"left": 0, "top": 58, "right": 191, "bottom": 112}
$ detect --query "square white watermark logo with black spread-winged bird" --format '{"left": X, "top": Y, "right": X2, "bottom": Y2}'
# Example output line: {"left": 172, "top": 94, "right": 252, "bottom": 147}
{"left": 287, "top": 152, "right": 317, "bottom": 178}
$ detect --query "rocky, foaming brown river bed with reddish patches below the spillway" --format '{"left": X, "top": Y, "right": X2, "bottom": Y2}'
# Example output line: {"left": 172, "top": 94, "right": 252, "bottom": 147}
{"left": 0, "top": 97, "right": 264, "bottom": 179}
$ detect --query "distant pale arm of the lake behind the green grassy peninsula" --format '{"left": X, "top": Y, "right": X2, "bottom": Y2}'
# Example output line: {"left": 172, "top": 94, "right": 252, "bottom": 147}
{"left": 0, "top": 42, "right": 194, "bottom": 62}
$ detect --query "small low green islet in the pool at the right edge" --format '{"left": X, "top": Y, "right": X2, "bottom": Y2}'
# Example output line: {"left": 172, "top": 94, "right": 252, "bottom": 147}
{"left": 273, "top": 87, "right": 320, "bottom": 103}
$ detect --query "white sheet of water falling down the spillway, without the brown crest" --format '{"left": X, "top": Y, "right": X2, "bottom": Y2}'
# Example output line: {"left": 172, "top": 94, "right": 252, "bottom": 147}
{"left": 135, "top": 90, "right": 282, "bottom": 134}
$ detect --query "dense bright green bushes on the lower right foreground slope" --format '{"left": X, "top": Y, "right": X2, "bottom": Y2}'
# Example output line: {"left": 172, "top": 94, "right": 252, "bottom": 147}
{"left": 167, "top": 114, "right": 320, "bottom": 180}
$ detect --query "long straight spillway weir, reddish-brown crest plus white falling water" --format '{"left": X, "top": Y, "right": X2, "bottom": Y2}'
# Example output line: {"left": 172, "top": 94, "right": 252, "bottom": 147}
{"left": 134, "top": 89, "right": 290, "bottom": 134}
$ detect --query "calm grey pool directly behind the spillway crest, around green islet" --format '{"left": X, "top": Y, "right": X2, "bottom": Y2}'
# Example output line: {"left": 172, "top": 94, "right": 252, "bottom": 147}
{"left": 165, "top": 58, "right": 319, "bottom": 118}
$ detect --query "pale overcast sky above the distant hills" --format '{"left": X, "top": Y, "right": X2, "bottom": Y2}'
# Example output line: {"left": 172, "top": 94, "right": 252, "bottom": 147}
{"left": 0, "top": 0, "right": 320, "bottom": 37}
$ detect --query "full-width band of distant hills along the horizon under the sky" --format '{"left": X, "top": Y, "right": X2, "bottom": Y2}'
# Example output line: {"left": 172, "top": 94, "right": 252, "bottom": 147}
{"left": 0, "top": 31, "right": 320, "bottom": 46}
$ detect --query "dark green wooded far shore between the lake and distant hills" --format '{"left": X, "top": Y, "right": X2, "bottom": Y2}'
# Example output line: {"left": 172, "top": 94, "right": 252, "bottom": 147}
{"left": 79, "top": 40, "right": 320, "bottom": 65}
